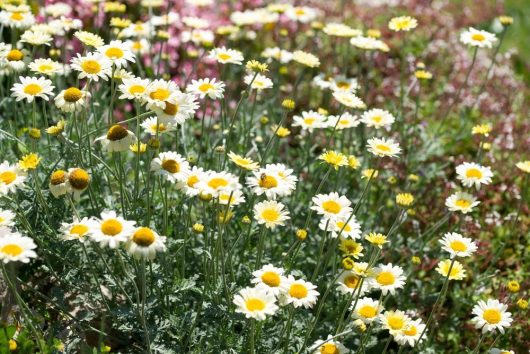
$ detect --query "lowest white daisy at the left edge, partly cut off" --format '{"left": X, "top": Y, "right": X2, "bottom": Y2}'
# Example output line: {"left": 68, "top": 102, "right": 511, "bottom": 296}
{"left": 0, "top": 228, "right": 37, "bottom": 263}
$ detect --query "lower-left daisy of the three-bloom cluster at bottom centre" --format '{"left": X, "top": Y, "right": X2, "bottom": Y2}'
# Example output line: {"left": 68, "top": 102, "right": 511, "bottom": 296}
{"left": 234, "top": 287, "right": 278, "bottom": 321}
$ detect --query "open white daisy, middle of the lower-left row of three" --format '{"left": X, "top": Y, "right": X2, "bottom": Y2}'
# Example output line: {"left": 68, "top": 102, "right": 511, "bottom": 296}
{"left": 89, "top": 211, "right": 136, "bottom": 249}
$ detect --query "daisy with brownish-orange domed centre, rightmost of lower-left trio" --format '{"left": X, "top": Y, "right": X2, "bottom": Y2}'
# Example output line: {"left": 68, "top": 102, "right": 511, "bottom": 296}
{"left": 125, "top": 227, "right": 166, "bottom": 260}
